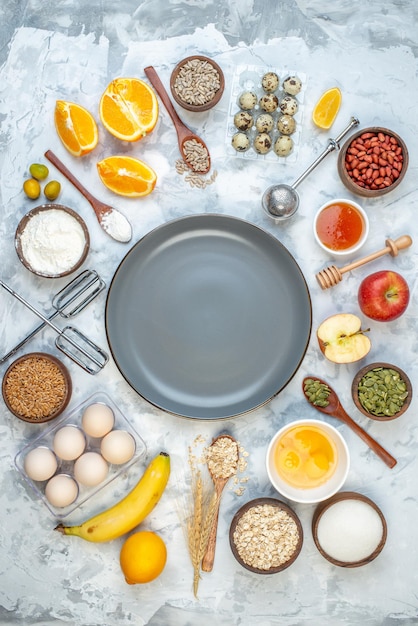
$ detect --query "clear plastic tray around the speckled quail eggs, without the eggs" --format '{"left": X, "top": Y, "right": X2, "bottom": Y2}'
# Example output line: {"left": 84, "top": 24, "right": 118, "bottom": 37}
{"left": 225, "top": 65, "right": 307, "bottom": 163}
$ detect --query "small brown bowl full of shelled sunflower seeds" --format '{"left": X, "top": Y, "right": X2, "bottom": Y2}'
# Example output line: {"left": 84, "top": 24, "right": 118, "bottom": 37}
{"left": 170, "top": 55, "right": 225, "bottom": 112}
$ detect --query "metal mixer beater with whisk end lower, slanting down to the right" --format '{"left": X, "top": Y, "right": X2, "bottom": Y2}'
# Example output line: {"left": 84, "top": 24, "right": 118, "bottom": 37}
{"left": 0, "top": 280, "right": 109, "bottom": 374}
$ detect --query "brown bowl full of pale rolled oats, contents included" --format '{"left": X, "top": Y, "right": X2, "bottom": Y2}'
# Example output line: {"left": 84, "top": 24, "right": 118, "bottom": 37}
{"left": 229, "top": 498, "right": 303, "bottom": 574}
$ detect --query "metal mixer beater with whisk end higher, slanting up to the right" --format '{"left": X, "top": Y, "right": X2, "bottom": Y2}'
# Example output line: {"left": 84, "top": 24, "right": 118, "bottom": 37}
{"left": 0, "top": 270, "right": 106, "bottom": 363}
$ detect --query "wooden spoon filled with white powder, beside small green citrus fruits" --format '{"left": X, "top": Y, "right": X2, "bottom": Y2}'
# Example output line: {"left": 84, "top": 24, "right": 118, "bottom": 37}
{"left": 45, "top": 150, "right": 132, "bottom": 243}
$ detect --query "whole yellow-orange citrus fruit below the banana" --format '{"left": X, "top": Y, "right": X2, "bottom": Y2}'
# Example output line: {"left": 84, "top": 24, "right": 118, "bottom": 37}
{"left": 120, "top": 530, "right": 167, "bottom": 585}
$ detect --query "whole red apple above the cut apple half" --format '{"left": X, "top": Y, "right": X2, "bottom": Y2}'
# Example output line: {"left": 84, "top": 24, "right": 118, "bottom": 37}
{"left": 358, "top": 270, "right": 409, "bottom": 322}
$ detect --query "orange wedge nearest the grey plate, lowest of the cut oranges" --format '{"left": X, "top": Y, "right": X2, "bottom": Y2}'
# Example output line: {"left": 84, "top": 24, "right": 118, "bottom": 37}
{"left": 97, "top": 156, "right": 157, "bottom": 198}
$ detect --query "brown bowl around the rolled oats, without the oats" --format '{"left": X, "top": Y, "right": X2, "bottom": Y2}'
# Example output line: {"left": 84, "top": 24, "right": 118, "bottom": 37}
{"left": 229, "top": 498, "right": 303, "bottom": 574}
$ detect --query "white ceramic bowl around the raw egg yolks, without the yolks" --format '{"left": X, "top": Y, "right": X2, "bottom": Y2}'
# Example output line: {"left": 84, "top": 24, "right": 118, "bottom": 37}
{"left": 266, "top": 419, "right": 350, "bottom": 504}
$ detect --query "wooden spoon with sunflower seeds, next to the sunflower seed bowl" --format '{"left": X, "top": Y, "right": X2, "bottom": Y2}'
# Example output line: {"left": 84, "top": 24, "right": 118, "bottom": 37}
{"left": 144, "top": 65, "right": 210, "bottom": 174}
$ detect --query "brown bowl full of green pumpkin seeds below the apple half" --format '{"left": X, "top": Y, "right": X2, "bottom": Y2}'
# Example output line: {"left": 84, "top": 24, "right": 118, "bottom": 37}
{"left": 351, "top": 362, "right": 412, "bottom": 421}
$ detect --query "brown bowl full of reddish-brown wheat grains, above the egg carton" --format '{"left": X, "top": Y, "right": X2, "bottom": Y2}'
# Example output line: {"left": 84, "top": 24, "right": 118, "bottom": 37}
{"left": 2, "top": 352, "right": 72, "bottom": 424}
